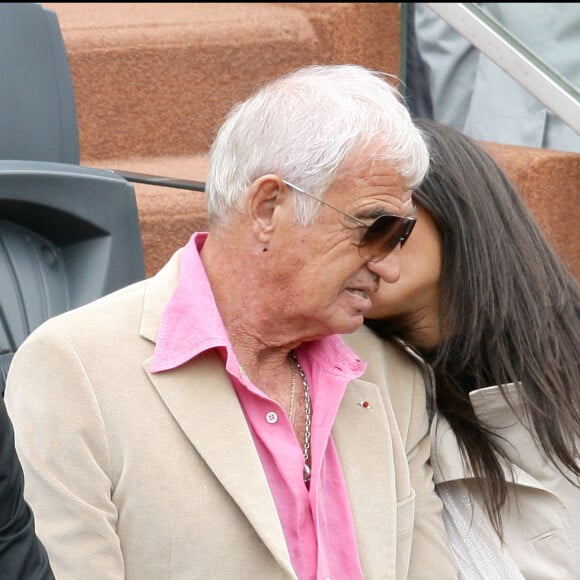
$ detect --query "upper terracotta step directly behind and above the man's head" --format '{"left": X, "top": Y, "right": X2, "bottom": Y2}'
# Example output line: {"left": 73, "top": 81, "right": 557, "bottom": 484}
{"left": 44, "top": 2, "right": 399, "bottom": 160}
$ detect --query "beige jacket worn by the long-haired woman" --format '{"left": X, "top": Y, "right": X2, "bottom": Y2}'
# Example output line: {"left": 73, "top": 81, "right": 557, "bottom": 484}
{"left": 432, "top": 384, "right": 580, "bottom": 580}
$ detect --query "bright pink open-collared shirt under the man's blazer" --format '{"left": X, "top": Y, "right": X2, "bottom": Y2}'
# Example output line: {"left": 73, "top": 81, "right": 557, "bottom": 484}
{"left": 151, "top": 232, "right": 365, "bottom": 580}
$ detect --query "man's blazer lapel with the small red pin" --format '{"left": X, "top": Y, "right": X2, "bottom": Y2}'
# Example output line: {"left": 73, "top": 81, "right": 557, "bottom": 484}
{"left": 333, "top": 379, "right": 398, "bottom": 579}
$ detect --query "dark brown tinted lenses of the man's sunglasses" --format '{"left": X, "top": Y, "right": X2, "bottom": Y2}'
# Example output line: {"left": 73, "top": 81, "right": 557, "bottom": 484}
{"left": 359, "top": 215, "right": 416, "bottom": 262}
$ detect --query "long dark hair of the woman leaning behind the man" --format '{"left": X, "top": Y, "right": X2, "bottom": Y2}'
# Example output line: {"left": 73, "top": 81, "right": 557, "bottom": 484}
{"left": 367, "top": 119, "right": 580, "bottom": 537}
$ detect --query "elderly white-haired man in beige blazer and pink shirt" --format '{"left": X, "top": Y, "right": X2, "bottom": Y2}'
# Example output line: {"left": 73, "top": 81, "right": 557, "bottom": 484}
{"left": 7, "top": 65, "right": 455, "bottom": 580}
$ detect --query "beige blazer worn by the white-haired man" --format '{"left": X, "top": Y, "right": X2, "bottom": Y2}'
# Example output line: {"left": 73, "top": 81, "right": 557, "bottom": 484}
{"left": 6, "top": 252, "right": 456, "bottom": 580}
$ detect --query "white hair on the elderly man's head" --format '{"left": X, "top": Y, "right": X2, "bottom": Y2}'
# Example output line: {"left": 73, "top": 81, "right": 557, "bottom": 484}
{"left": 206, "top": 64, "right": 429, "bottom": 223}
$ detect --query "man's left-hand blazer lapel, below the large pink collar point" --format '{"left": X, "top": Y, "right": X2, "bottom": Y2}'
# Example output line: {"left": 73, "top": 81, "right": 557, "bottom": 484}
{"left": 144, "top": 351, "right": 292, "bottom": 573}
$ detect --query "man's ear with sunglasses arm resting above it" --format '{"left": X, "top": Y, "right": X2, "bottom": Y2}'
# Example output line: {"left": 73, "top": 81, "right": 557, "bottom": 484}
{"left": 247, "top": 175, "right": 284, "bottom": 244}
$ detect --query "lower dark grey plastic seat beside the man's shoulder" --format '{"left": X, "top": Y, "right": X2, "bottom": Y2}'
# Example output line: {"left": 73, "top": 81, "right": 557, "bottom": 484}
{"left": 0, "top": 160, "right": 145, "bottom": 392}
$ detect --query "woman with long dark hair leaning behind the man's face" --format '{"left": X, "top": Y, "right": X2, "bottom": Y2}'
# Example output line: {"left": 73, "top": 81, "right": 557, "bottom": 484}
{"left": 367, "top": 119, "right": 580, "bottom": 580}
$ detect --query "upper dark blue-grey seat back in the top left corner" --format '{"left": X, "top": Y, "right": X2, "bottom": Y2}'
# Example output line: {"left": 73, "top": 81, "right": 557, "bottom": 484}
{"left": 0, "top": 2, "right": 79, "bottom": 165}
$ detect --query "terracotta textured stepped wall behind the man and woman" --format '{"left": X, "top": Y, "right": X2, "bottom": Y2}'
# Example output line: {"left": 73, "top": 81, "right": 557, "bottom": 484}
{"left": 44, "top": 2, "right": 580, "bottom": 278}
